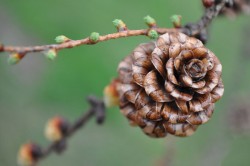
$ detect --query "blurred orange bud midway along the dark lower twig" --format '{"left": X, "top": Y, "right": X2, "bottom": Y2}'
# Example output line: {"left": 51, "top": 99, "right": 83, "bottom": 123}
{"left": 45, "top": 117, "right": 69, "bottom": 142}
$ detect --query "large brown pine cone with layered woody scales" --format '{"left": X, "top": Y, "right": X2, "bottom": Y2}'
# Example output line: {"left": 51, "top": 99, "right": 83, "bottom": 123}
{"left": 117, "top": 33, "right": 224, "bottom": 137}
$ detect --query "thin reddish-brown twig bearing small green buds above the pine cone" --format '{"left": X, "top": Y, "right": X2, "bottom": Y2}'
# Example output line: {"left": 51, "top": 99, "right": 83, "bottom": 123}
{"left": 0, "top": 0, "right": 227, "bottom": 54}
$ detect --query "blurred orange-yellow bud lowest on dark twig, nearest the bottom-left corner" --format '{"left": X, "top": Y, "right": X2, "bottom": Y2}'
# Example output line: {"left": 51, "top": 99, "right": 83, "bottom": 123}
{"left": 17, "top": 143, "right": 42, "bottom": 166}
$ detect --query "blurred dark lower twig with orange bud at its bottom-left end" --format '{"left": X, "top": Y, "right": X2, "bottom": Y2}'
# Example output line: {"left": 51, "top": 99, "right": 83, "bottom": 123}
{"left": 18, "top": 96, "right": 106, "bottom": 166}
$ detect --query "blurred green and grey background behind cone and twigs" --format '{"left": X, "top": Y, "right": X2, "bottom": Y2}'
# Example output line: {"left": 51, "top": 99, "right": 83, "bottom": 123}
{"left": 0, "top": 0, "right": 250, "bottom": 166}
